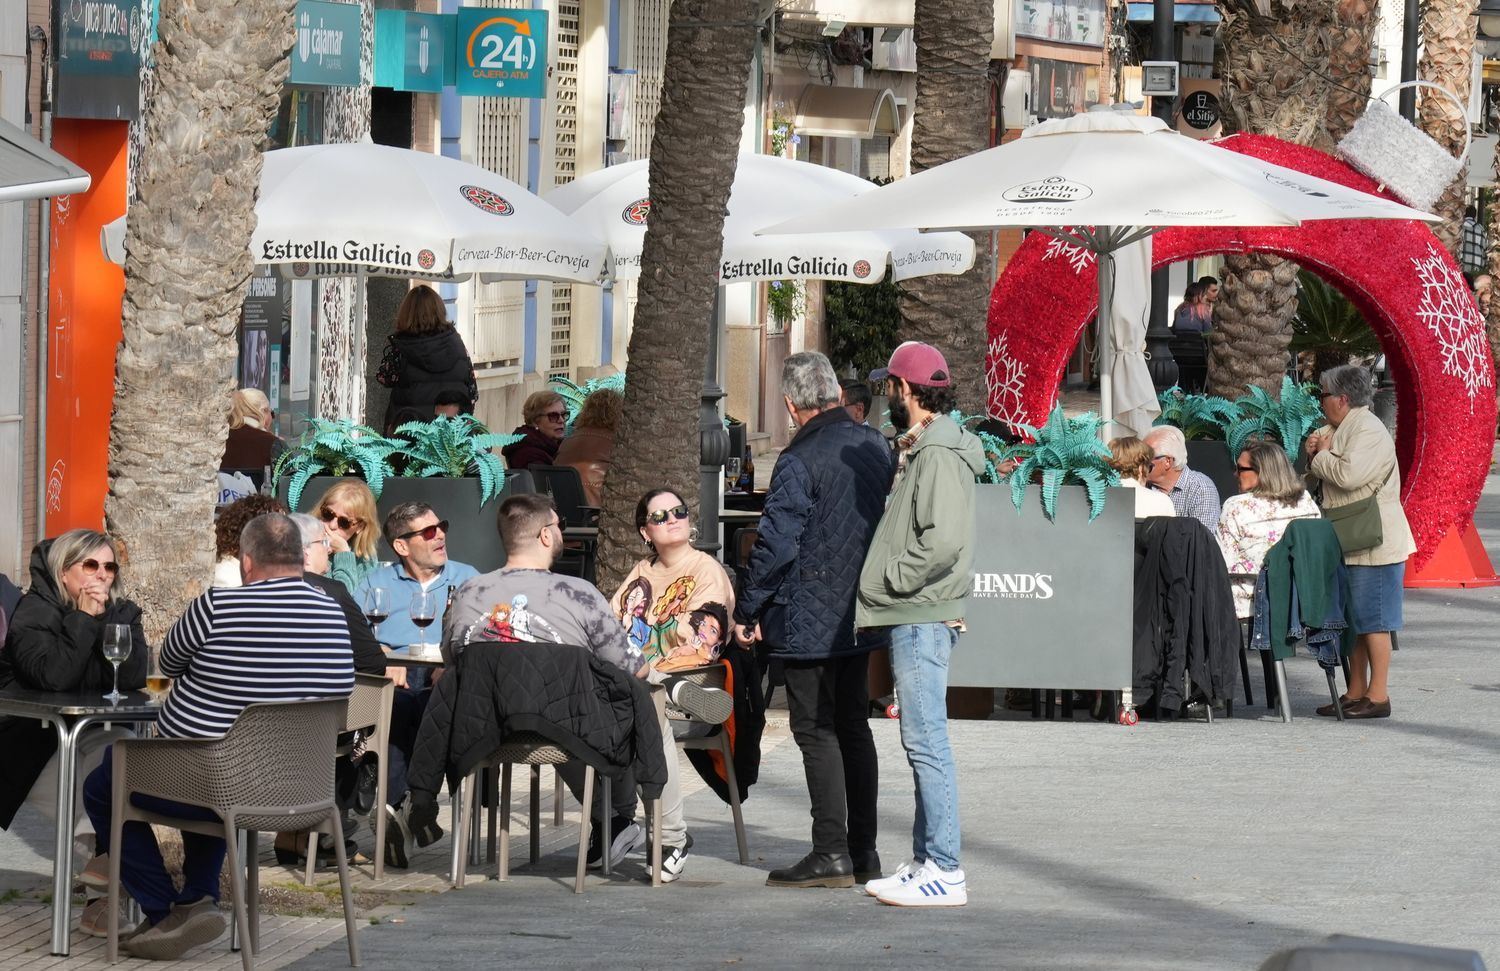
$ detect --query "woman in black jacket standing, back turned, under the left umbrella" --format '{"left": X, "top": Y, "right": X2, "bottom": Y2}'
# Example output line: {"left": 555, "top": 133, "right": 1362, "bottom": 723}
{"left": 375, "top": 285, "right": 479, "bottom": 426}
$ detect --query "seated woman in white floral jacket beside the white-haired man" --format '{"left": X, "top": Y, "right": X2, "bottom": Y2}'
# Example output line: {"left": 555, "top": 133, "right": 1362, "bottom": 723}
{"left": 1218, "top": 441, "right": 1323, "bottom": 620}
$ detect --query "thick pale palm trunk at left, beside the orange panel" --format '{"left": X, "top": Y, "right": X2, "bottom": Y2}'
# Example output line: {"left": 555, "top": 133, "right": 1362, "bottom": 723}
{"left": 105, "top": 0, "right": 293, "bottom": 639}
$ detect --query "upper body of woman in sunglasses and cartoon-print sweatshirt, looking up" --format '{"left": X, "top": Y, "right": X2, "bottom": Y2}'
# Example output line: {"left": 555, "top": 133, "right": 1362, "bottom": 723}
{"left": 612, "top": 489, "right": 735, "bottom": 671}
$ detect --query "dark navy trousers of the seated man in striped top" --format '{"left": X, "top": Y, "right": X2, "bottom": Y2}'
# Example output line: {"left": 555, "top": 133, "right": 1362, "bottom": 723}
{"left": 84, "top": 746, "right": 225, "bottom": 924}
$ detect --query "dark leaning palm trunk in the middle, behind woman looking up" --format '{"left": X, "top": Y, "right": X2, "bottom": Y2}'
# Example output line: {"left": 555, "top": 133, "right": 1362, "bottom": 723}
{"left": 599, "top": 0, "right": 759, "bottom": 591}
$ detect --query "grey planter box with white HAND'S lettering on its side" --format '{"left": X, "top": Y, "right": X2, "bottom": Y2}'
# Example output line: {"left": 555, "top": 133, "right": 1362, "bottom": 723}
{"left": 948, "top": 485, "right": 1136, "bottom": 690}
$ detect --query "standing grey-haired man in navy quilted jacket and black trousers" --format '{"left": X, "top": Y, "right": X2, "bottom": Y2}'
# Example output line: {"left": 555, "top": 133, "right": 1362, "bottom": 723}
{"left": 735, "top": 351, "right": 896, "bottom": 887}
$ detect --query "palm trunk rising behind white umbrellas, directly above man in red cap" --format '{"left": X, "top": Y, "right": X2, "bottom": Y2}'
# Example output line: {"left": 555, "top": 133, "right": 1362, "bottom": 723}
{"left": 902, "top": 0, "right": 995, "bottom": 414}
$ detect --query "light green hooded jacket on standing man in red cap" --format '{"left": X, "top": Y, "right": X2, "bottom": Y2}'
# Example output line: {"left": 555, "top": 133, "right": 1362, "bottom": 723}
{"left": 857, "top": 414, "right": 984, "bottom": 627}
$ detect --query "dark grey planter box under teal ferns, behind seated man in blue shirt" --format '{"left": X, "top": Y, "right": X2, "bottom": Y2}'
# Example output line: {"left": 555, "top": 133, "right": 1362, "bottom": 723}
{"left": 276, "top": 476, "right": 510, "bottom": 573}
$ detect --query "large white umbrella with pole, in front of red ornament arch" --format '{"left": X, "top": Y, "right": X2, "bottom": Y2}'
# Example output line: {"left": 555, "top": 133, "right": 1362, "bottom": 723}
{"left": 762, "top": 111, "right": 1439, "bottom": 432}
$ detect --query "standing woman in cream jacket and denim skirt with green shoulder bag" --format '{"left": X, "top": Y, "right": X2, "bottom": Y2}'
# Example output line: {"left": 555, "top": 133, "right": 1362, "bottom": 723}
{"left": 1304, "top": 365, "right": 1416, "bottom": 719}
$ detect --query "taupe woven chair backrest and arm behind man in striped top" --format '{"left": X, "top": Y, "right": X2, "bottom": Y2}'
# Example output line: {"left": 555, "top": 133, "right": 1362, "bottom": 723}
{"left": 139, "top": 698, "right": 348, "bottom": 828}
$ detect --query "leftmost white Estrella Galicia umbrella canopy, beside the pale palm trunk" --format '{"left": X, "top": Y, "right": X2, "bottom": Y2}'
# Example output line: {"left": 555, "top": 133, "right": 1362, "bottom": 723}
{"left": 251, "top": 143, "right": 606, "bottom": 284}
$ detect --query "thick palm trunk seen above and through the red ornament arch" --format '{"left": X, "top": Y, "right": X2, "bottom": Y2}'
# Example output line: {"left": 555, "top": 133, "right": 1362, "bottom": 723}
{"left": 1209, "top": 0, "right": 1338, "bottom": 398}
